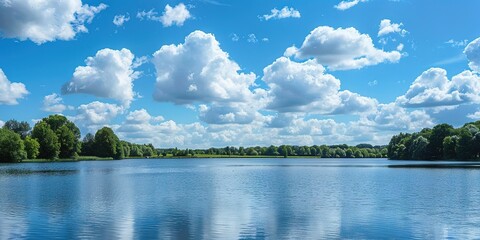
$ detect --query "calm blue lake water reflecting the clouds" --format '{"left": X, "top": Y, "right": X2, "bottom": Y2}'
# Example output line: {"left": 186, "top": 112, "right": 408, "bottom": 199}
{"left": 0, "top": 159, "right": 480, "bottom": 239}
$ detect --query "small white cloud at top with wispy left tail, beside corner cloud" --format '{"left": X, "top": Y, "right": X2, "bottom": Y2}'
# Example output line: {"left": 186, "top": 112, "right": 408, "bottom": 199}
{"left": 137, "top": 3, "right": 192, "bottom": 27}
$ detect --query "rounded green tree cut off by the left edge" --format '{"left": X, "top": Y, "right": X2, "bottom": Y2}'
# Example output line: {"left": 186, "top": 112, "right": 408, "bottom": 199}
{"left": 0, "top": 128, "right": 27, "bottom": 162}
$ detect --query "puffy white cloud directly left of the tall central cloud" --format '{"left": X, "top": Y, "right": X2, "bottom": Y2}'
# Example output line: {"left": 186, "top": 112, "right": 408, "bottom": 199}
{"left": 62, "top": 48, "right": 139, "bottom": 107}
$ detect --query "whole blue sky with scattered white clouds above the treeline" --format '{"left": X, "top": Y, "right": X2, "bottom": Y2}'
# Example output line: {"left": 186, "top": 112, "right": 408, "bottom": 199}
{"left": 0, "top": 0, "right": 480, "bottom": 148}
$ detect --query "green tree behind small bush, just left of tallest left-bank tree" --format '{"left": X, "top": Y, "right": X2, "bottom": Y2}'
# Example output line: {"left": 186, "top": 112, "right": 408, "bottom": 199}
{"left": 32, "top": 121, "right": 60, "bottom": 159}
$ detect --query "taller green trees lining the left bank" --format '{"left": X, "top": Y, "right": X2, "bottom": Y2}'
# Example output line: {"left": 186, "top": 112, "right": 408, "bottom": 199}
{"left": 0, "top": 115, "right": 156, "bottom": 162}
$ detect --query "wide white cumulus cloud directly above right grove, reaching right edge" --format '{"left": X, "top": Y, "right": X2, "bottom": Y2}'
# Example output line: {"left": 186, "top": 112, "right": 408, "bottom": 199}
{"left": 396, "top": 68, "right": 480, "bottom": 107}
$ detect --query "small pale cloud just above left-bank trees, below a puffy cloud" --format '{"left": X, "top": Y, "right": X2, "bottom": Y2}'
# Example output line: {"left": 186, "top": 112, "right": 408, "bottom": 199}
{"left": 69, "top": 101, "right": 124, "bottom": 133}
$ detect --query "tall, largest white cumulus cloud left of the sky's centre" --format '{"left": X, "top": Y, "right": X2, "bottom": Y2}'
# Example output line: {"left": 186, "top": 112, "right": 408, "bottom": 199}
{"left": 152, "top": 31, "right": 256, "bottom": 104}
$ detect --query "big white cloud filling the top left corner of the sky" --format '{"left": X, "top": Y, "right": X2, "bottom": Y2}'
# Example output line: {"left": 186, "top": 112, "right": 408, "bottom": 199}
{"left": 0, "top": 0, "right": 107, "bottom": 44}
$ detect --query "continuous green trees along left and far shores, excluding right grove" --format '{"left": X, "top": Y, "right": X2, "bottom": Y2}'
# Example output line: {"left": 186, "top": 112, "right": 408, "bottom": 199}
{"left": 0, "top": 115, "right": 387, "bottom": 162}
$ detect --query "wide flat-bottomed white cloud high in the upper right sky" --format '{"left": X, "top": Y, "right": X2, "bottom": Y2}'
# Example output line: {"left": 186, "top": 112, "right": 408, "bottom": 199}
{"left": 285, "top": 26, "right": 402, "bottom": 70}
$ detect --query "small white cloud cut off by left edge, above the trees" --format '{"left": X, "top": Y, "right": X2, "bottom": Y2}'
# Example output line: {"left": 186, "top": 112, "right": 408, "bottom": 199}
{"left": 0, "top": 68, "right": 29, "bottom": 105}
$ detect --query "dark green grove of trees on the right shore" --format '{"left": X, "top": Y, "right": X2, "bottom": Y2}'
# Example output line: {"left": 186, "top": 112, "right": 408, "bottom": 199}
{"left": 387, "top": 121, "right": 480, "bottom": 160}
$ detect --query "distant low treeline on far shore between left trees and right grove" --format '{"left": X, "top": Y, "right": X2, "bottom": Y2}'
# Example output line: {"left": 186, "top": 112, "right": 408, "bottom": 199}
{"left": 157, "top": 144, "right": 387, "bottom": 158}
